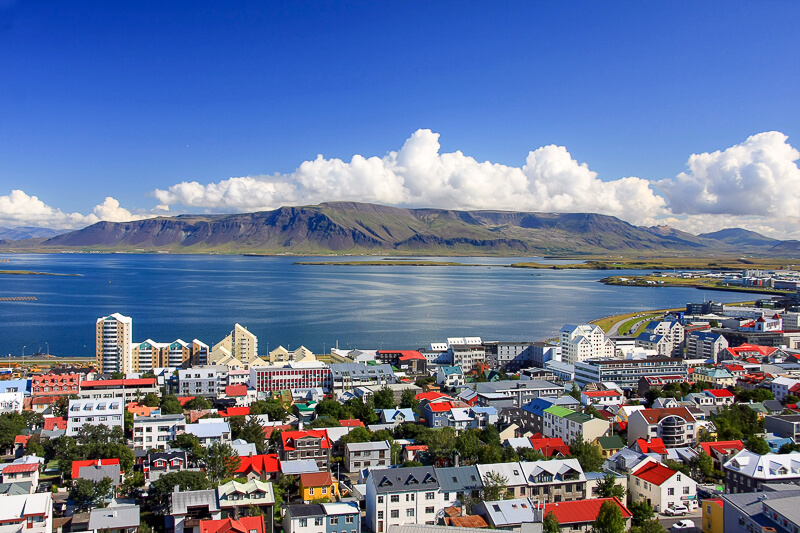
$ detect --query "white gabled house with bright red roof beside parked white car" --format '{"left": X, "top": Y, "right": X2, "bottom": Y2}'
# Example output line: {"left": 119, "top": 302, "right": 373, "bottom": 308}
{"left": 628, "top": 462, "right": 697, "bottom": 512}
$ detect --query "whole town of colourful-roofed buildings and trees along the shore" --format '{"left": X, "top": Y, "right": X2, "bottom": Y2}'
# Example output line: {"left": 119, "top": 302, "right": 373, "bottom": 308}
{"left": 0, "top": 292, "right": 800, "bottom": 533}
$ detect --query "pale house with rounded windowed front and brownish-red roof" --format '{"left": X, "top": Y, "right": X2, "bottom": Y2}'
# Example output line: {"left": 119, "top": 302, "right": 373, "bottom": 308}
{"left": 628, "top": 407, "right": 697, "bottom": 448}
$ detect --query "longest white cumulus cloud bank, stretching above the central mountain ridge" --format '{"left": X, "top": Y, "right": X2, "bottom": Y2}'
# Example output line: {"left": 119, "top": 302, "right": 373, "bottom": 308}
{"left": 153, "top": 129, "right": 665, "bottom": 221}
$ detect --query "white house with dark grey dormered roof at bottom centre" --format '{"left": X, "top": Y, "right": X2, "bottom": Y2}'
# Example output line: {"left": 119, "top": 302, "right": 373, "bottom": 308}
{"left": 365, "top": 466, "right": 443, "bottom": 533}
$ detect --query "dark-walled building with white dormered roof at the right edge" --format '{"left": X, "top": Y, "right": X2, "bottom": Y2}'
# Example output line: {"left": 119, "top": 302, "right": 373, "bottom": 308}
{"left": 722, "top": 450, "right": 800, "bottom": 493}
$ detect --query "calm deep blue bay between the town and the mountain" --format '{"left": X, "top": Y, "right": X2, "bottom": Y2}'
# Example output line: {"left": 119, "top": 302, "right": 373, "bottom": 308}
{"left": 0, "top": 254, "right": 768, "bottom": 356}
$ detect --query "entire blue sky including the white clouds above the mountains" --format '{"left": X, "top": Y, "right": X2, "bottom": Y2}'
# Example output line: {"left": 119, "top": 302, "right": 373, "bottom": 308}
{"left": 0, "top": 0, "right": 800, "bottom": 236}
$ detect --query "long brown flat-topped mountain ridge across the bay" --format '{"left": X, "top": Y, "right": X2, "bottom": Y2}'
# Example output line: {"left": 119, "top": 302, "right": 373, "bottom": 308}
{"left": 2, "top": 202, "right": 792, "bottom": 255}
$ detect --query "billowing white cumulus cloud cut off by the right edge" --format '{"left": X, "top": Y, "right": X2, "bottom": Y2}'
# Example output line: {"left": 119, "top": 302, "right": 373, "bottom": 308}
{"left": 659, "top": 131, "right": 800, "bottom": 217}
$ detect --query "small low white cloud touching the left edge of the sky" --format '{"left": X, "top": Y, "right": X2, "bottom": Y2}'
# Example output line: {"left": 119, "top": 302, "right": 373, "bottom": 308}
{"left": 0, "top": 189, "right": 152, "bottom": 229}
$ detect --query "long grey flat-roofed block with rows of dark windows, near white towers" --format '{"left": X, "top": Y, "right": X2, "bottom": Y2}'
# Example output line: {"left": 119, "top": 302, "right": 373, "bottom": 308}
{"left": 575, "top": 357, "right": 689, "bottom": 391}
